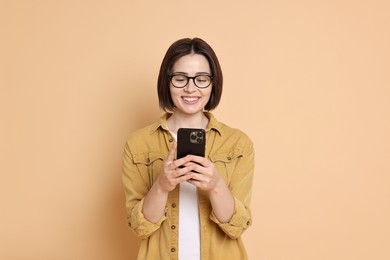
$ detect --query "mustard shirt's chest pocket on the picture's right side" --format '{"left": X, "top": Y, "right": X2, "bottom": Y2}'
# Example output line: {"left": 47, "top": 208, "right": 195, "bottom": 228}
{"left": 209, "top": 149, "right": 243, "bottom": 185}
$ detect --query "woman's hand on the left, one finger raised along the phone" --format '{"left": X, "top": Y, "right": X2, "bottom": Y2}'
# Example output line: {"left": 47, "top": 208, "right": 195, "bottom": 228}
{"left": 156, "top": 142, "right": 196, "bottom": 193}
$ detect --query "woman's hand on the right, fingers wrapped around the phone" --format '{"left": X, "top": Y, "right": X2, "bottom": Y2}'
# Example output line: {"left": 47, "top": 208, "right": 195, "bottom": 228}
{"left": 185, "top": 155, "right": 226, "bottom": 192}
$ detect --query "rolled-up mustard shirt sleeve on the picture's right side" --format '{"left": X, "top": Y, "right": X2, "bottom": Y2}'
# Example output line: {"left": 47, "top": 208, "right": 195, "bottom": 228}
{"left": 210, "top": 137, "right": 254, "bottom": 239}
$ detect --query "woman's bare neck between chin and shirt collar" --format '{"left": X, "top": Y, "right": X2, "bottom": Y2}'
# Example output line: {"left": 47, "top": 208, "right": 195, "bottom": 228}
{"left": 167, "top": 112, "right": 209, "bottom": 133}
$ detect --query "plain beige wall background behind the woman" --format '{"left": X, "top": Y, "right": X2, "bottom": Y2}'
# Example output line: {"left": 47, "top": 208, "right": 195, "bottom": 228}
{"left": 0, "top": 0, "right": 390, "bottom": 260}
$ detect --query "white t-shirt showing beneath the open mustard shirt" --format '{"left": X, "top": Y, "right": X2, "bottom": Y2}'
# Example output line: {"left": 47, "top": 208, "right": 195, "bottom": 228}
{"left": 171, "top": 132, "right": 200, "bottom": 260}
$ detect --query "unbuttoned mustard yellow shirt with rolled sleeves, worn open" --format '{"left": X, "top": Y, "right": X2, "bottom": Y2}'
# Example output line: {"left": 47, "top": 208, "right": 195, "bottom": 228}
{"left": 122, "top": 113, "right": 254, "bottom": 260}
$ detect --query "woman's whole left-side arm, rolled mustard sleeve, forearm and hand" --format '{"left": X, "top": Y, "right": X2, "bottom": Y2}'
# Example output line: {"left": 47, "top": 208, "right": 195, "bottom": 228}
{"left": 122, "top": 143, "right": 198, "bottom": 238}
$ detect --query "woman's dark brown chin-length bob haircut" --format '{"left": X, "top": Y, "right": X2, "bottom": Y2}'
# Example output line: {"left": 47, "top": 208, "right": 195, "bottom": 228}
{"left": 157, "top": 38, "right": 223, "bottom": 111}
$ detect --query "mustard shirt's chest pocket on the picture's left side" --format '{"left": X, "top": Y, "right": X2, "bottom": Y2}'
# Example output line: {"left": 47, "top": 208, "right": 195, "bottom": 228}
{"left": 133, "top": 152, "right": 166, "bottom": 188}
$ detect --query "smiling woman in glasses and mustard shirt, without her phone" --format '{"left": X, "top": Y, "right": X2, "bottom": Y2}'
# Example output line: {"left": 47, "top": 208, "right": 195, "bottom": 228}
{"left": 123, "top": 38, "right": 254, "bottom": 260}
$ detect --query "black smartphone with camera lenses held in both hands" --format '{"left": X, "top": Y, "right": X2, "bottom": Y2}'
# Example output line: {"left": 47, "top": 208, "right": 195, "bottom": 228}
{"left": 177, "top": 128, "right": 206, "bottom": 159}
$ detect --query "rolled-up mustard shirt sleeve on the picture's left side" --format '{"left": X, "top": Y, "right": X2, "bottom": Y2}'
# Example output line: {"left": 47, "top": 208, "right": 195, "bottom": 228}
{"left": 122, "top": 142, "right": 167, "bottom": 238}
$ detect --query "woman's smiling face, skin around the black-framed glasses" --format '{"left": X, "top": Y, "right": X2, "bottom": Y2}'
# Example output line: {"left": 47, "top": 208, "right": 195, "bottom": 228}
{"left": 170, "top": 54, "right": 213, "bottom": 115}
